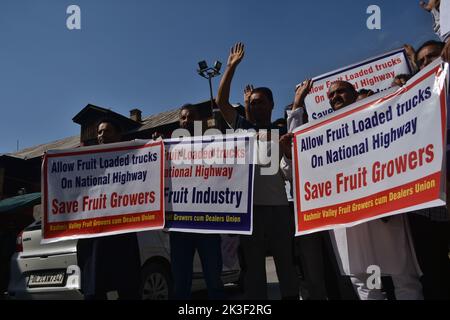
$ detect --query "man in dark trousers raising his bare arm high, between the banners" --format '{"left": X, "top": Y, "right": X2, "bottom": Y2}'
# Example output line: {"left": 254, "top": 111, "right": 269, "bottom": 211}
{"left": 216, "top": 43, "right": 299, "bottom": 300}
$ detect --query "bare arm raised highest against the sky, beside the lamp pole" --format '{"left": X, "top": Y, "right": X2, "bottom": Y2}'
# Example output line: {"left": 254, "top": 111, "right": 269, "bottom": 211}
{"left": 216, "top": 42, "right": 244, "bottom": 125}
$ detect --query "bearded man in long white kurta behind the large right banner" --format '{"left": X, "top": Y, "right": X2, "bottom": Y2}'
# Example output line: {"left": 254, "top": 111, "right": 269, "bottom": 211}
{"left": 281, "top": 81, "right": 423, "bottom": 300}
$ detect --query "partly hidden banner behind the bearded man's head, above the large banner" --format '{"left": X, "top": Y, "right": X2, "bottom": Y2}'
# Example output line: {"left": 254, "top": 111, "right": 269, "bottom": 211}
{"left": 305, "top": 49, "right": 411, "bottom": 120}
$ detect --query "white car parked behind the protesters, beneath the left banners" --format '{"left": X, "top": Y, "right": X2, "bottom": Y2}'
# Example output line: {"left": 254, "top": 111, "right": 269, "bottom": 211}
{"left": 8, "top": 221, "right": 239, "bottom": 300}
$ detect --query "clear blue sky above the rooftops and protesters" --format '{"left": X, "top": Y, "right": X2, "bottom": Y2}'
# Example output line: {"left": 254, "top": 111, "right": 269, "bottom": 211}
{"left": 0, "top": 0, "right": 436, "bottom": 153}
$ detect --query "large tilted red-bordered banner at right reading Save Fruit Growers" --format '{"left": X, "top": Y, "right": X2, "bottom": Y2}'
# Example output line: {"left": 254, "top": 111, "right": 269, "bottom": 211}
{"left": 293, "top": 62, "right": 448, "bottom": 235}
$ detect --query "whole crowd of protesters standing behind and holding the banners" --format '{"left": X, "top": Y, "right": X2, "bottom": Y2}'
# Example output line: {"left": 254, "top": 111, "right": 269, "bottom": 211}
{"left": 75, "top": 1, "right": 450, "bottom": 300}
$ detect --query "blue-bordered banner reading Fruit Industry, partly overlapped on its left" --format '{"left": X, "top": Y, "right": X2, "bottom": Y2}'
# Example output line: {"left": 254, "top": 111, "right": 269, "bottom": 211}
{"left": 164, "top": 134, "right": 255, "bottom": 234}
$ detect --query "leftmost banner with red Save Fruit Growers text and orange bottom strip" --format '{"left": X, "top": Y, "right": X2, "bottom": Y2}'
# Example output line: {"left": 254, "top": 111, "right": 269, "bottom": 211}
{"left": 42, "top": 140, "right": 164, "bottom": 242}
